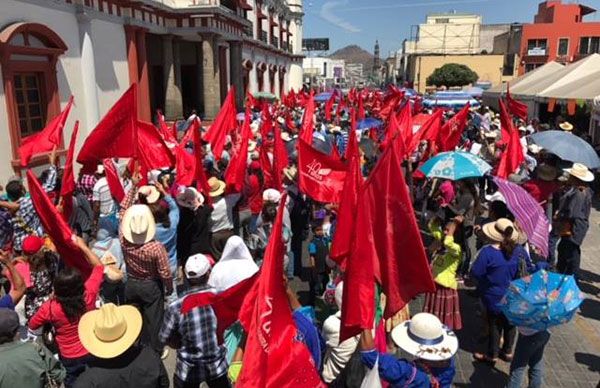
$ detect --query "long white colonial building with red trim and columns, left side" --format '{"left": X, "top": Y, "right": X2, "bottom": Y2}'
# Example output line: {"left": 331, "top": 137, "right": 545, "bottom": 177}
{"left": 0, "top": 0, "right": 303, "bottom": 182}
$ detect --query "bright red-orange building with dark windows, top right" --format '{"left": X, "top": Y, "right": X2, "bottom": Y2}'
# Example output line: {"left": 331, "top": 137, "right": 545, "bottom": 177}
{"left": 519, "top": 0, "right": 600, "bottom": 74}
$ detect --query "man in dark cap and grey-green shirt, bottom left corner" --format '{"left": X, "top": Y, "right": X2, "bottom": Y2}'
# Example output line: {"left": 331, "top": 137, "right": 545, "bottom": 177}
{"left": 0, "top": 308, "right": 66, "bottom": 388}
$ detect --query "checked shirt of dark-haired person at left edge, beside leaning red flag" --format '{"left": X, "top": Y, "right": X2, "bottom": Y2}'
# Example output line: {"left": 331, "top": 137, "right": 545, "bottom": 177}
{"left": 12, "top": 166, "right": 56, "bottom": 251}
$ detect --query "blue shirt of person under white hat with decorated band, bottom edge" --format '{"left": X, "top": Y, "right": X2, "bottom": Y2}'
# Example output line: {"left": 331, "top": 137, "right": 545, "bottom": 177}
{"left": 360, "top": 349, "right": 456, "bottom": 388}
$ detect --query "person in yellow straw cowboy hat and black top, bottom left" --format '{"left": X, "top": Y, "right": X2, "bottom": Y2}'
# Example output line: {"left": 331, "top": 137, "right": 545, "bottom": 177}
{"left": 74, "top": 303, "right": 169, "bottom": 388}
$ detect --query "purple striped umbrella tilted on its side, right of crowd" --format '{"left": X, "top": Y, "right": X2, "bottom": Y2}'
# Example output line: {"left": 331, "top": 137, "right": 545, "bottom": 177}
{"left": 494, "top": 177, "right": 550, "bottom": 257}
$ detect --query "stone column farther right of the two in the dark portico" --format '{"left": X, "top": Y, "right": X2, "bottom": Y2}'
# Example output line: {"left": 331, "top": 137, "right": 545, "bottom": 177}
{"left": 202, "top": 34, "right": 221, "bottom": 119}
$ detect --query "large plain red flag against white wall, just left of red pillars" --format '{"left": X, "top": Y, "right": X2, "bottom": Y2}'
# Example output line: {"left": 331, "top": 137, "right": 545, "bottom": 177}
{"left": 77, "top": 84, "right": 137, "bottom": 164}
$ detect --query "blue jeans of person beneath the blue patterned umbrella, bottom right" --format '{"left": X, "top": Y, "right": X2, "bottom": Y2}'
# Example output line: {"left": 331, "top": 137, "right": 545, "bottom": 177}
{"left": 506, "top": 330, "right": 550, "bottom": 388}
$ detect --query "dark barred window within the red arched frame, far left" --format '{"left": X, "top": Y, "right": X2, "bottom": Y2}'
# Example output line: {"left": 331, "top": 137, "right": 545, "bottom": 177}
{"left": 14, "top": 73, "right": 46, "bottom": 137}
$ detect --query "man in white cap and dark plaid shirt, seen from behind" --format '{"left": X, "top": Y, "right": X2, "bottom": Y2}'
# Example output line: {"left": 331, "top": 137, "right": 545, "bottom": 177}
{"left": 160, "top": 253, "right": 231, "bottom": 388}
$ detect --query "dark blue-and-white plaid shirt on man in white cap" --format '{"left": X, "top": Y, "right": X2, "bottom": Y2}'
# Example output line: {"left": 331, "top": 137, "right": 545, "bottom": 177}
{"left": 159, "top": 287, "right": 228, "bottom": 383}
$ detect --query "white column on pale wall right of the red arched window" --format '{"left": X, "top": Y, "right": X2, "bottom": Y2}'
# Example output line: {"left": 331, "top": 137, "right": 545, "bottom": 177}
{"left": 77, "top": 12, "right": 100, "bottom": 131}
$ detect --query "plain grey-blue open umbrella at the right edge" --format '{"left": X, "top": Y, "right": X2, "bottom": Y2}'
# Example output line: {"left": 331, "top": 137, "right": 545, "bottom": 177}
{"left": 531, "top": 131, "right": 600, "bottom": 169}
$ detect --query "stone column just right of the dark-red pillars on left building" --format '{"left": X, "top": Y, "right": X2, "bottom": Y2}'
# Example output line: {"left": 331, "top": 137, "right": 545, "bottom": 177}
{"left": 162, "top": 35, "right": 183, "bottom": 120}
